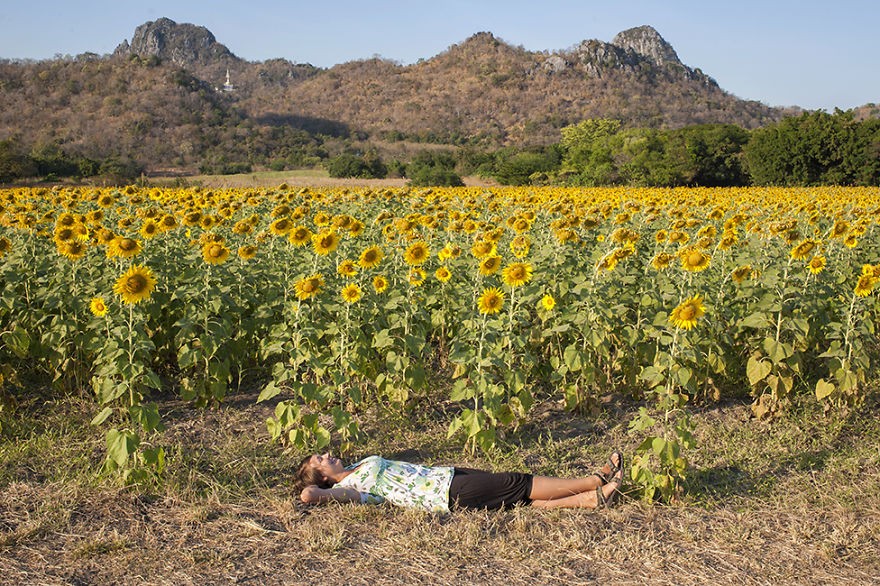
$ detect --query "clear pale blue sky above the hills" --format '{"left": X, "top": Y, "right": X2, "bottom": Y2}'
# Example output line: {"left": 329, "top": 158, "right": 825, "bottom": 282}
{"left": 0, "top": 0, "right": 880, "bottom": 110}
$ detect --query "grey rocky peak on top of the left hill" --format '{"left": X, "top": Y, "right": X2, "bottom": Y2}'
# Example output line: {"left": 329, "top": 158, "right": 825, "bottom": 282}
{"left": 115, "top": 18, "right": 238, "bottom": 66}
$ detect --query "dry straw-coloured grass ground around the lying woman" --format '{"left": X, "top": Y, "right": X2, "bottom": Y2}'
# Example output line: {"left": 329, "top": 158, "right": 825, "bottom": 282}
{"left": 0, "top": 390, "right": 880, "bottom": 585}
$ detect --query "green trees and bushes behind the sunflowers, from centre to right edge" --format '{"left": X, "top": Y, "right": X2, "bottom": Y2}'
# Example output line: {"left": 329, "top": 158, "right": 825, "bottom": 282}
{"left": 329, "top": 110, "right": 880, "bottom": 187}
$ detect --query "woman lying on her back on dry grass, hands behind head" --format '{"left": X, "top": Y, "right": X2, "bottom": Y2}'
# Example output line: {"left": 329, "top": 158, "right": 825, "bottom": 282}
{"left": 296, "top": 450, "right": 623, "bottom": 513}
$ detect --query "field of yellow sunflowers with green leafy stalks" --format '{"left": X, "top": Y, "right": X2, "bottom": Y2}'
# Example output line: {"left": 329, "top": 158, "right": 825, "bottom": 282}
{"left": 0, "top": 185, "right": 880, "bottom": 498}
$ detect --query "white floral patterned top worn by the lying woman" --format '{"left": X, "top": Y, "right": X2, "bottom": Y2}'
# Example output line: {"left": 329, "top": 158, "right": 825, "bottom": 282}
{"left": 336, "top": 456, "right": 455, "bottom": 513}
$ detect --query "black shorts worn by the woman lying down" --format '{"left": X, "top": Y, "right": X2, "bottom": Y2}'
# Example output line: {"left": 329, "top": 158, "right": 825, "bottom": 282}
{"left": 449, "top": 468, "right": 532, "bottom": 509}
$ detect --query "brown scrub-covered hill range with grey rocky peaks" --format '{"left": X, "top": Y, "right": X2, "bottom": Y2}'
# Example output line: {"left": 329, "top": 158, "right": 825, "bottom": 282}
{"left": 0, "top": 18, "right": 808, "bottom": 168}
